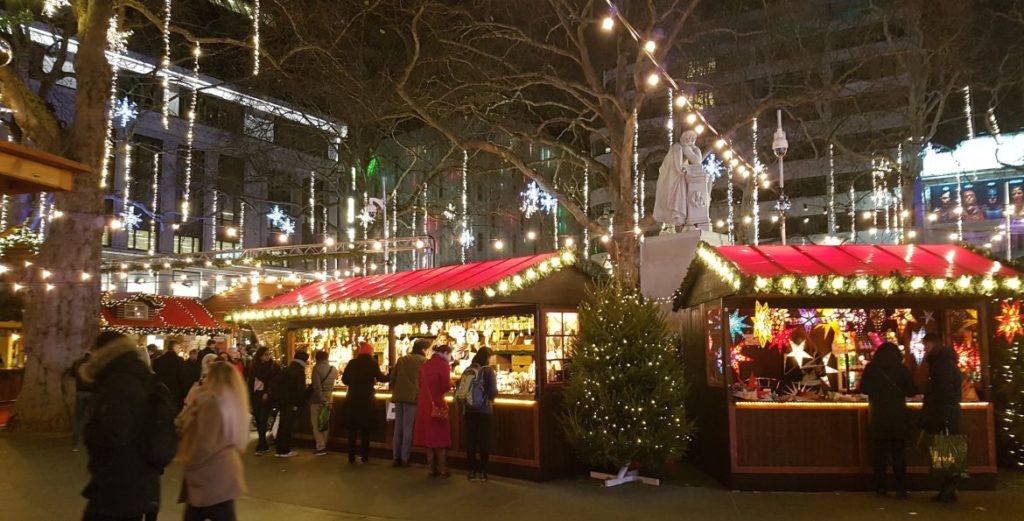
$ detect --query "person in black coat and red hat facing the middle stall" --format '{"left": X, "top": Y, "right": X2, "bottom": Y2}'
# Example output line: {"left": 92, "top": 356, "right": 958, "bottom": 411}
{"left": 341, "top": 342, "right": 387, "bottom": 463}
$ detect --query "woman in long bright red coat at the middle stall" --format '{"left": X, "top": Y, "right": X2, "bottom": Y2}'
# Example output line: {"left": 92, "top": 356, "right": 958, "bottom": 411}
{"left": 413, "top": 344, "right": 452, "bottom": 478}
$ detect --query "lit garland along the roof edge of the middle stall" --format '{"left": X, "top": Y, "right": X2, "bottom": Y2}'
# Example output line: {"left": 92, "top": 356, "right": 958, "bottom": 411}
{"left": 225, "top": 249, "right": 581, "bottom": 322}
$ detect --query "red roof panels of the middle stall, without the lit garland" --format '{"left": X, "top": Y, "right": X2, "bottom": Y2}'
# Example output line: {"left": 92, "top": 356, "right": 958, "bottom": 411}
{"left": 253, "top": 252, "right": 561, "bottom": 309}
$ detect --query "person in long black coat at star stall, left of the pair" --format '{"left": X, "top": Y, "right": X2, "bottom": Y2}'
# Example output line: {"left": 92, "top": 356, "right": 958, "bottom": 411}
{"left": 860, "top": 342, "right": 913, "bottom": 498}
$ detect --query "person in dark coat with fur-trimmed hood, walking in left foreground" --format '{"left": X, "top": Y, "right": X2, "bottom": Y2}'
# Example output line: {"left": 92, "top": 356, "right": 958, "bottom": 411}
{"left": 80, "top": 332, "right": 162, "bottom": 521}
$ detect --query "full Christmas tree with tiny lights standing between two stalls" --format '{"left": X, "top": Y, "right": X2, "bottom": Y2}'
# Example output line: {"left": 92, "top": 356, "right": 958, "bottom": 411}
{"left": 564, "top": 281, "right": 692, "bottom": 469}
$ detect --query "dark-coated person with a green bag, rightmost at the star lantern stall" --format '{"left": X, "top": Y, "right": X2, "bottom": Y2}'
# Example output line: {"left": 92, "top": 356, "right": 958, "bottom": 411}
{"left": 921, "top": 333, "right": 961, "bottom": 503}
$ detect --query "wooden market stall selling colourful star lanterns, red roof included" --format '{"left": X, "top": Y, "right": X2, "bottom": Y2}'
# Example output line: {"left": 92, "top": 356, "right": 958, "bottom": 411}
{"left": 673, "top": 244, "right": 1007, "bottom": 490}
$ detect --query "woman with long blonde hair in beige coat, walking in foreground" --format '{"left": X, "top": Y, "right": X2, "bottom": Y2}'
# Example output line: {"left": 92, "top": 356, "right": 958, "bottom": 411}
{"left": 179, "top": 361, "right": 249, "bottom": 521}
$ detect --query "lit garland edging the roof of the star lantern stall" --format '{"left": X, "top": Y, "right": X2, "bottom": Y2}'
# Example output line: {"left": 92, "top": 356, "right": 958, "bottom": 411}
{"left": 673, "top": 244, "right": 1024, "bottom": 310}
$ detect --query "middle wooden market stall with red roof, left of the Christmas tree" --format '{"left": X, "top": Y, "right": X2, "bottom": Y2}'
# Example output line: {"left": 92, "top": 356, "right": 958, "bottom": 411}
{"left": 228, "top": 251, "right": 588, "bottom": 479}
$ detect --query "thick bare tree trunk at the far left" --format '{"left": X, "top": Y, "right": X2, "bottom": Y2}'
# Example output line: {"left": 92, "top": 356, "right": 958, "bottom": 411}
{"left": 7, "top": 0, "right": 114, "bottom": 431}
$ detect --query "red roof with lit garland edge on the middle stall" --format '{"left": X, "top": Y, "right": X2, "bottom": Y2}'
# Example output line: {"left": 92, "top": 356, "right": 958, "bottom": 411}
{"left": 228, "top": 250, "right": 589, "bottom": 321}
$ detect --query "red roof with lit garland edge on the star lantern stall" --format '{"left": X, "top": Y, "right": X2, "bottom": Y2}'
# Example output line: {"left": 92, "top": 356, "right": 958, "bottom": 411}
{"left": 674, "top": 244, "right": 1022, "bottom": 309}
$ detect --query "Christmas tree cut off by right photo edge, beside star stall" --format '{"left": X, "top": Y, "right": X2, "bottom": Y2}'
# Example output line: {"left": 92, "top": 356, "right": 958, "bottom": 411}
{"left": 994, "top": 338, "right": 1024, "bottom": 469}
